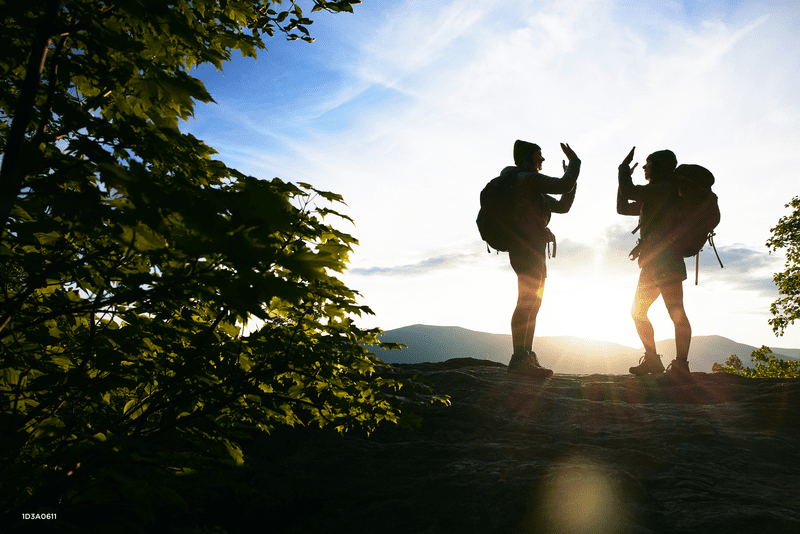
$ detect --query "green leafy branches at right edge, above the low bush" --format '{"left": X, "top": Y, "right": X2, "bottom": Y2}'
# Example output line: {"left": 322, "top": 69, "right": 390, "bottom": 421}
{"left": 767, "top": 197, "right": 800, "bottom": 336}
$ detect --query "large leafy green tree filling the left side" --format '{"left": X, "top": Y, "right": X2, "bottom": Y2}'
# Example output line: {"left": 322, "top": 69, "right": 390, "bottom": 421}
{"left": 0, "top": 0, "right": 444, "bottom": 525}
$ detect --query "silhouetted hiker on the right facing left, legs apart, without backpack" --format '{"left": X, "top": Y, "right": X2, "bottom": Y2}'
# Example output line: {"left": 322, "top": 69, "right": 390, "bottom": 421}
{"left": 617, "top": 147, "right": 692, "bottom": 376}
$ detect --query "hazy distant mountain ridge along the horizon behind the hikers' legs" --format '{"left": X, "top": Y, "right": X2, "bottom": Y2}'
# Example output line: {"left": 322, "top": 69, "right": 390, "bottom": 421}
{"left": 374, "top": 324, "right": 800, "bottom": 375}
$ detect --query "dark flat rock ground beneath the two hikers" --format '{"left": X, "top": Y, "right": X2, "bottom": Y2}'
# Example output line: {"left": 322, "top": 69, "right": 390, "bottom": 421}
{"left": 250, "top": 359, "right": 800, "bottom": 534}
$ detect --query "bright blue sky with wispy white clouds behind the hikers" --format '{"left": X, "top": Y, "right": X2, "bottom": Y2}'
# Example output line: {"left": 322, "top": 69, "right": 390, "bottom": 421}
{"left": 185, "top": 0, "right": 800, "bottom": 358}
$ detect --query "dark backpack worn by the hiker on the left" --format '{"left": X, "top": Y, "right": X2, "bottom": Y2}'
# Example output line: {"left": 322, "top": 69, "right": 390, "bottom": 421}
{"left": 475, "top": 169, "right": 555, "bottom": 256}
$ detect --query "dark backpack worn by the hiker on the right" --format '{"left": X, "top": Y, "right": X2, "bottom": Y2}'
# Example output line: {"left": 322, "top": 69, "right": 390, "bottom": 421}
{"left": 670, "top": 165, "right": 722, "bottom": 260}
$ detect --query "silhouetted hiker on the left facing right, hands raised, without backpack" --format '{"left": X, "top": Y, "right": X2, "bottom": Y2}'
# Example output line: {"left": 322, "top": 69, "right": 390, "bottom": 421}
{"left": 500, "top": 140, "right": 581, "bottom": 377}
